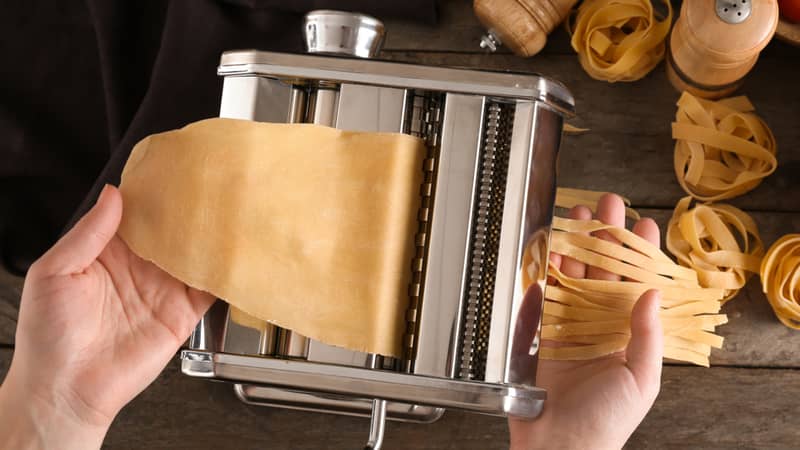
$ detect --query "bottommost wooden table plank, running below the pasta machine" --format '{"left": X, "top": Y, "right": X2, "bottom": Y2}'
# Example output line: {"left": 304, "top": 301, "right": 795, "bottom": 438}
{"left": 0, "top": 349, "right": 800, "bottom": 450}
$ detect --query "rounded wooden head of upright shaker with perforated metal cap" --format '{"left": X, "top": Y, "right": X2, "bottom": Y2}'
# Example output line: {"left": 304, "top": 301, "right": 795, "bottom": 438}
{"left": 681, "top": 0, "right": 778, "bottom": 60}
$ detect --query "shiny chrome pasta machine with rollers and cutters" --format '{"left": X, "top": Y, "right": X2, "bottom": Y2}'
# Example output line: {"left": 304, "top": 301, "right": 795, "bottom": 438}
{"left": 181, "top": 11, "right": 574, "bottom": 448}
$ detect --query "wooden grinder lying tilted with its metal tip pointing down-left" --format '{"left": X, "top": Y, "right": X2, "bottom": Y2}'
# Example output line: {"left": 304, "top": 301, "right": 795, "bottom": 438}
{"left": 473, "top": 0, "right": 577, "bottom": 57}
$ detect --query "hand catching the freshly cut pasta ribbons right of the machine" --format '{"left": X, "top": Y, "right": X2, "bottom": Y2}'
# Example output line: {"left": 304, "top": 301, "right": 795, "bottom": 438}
{"left": 509, "top": 195, "right": 663, "bottom": 449}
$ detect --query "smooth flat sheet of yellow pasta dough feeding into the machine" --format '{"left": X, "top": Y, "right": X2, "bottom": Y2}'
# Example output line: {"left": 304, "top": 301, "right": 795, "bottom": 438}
{"left": 119, "top": 119, "right": 425, "bottom": 356}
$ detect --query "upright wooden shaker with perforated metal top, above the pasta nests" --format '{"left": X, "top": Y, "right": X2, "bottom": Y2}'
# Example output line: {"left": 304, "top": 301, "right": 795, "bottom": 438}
{"left": 667, "top": 0, "right": 778, "bottom": 99}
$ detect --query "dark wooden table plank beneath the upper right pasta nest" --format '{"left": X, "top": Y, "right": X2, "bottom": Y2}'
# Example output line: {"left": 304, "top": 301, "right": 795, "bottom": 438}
{"left": 380, "top": 50, "right": 800, "bottom": 211}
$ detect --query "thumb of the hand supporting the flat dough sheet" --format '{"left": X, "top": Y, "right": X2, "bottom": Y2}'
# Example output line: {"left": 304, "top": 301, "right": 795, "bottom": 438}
{"left": 31, "top": 185, "right": 122, "bottom": 276}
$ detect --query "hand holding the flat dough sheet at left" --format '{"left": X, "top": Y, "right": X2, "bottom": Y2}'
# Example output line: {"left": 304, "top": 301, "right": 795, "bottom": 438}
{"left": 0, "top": 186, "right": 214, "bottom": 448}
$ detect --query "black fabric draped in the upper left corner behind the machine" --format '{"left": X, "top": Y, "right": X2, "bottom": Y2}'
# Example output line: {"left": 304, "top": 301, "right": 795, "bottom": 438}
{"left": 0, "top": 0, "right": 436, "bottom": 272}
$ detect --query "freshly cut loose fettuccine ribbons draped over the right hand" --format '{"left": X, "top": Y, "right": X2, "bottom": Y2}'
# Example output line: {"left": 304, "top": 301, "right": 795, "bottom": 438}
{"left": 528, "top": 217, "right": 727, "bottom": 366}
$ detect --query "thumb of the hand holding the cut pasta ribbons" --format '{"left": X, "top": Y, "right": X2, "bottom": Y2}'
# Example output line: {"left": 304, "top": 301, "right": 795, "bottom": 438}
{"left": 625, "top": 289, "right": 664, "bottom": 402}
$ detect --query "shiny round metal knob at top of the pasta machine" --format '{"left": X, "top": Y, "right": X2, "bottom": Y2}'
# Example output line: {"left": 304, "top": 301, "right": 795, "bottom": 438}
{"left": 304, "top": 10, "right": 385, "bottom": 58}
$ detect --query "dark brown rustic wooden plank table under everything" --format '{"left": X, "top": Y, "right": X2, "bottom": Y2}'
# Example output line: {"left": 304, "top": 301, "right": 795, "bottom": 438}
{"left": 0, "top": 0, "right": 800, "bottom": 449}
